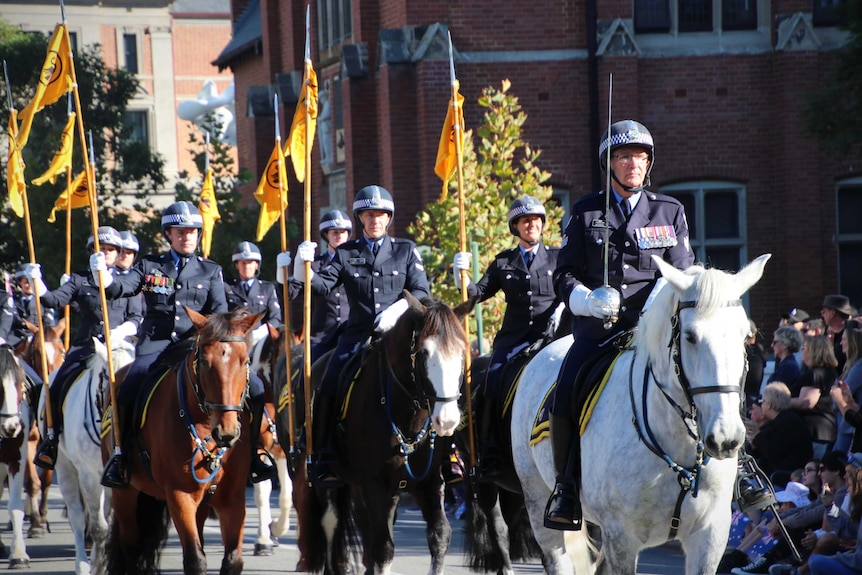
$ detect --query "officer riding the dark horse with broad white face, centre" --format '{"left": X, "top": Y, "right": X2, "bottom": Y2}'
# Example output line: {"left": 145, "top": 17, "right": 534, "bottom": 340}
{"left": 286, "top": 186, "right": 431, "bottom": 486}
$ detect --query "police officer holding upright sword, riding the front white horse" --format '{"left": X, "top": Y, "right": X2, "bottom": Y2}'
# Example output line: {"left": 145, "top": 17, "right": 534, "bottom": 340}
{"left": 545, "top": 120, "right": 694, "bottom": 530}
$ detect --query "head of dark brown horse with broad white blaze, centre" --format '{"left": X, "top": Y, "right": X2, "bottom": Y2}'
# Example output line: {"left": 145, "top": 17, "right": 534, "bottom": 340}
{"left": 386, "top": 290, "right": 477, "bottom": 436}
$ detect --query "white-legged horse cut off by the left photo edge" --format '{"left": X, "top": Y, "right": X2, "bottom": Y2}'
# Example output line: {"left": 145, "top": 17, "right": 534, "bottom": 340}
{"left": 0, "top": 347, "right": 30, "bottom": 569}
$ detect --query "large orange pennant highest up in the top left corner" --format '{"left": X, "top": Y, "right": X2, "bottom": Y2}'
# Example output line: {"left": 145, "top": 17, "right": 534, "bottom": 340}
{"left": 18, "top": 24, "right": 74, "bottom": 149}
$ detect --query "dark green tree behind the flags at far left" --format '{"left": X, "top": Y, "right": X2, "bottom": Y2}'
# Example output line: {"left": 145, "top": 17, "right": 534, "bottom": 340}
{"left": 0, "top": 22, "right": 165, "bottom": 287}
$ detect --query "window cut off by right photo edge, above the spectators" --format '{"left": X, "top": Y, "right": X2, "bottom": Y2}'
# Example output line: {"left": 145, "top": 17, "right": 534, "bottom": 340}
{"left": 836, "top": 179, "right": 862, "bottom": 305}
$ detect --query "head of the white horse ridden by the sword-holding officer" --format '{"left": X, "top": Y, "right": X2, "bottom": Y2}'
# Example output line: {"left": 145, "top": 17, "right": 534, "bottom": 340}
{"left": 636, "top": 254, "right": 770, "bottom": 459}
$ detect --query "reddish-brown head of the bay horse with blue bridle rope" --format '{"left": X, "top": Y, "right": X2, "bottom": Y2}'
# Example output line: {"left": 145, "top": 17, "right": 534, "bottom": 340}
{"left": 184, "top": 306, "right": 263, "bottom": 447}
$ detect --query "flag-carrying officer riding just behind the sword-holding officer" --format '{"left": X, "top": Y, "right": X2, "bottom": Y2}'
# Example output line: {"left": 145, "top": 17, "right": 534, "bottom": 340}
{"left": 453, "top": 196, "right": 563, "bottom": 481}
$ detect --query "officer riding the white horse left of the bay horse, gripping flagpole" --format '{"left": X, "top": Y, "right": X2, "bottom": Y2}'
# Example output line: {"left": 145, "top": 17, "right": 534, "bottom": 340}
{"left": 26, "top": 226, "right": 144, "bottom": 469}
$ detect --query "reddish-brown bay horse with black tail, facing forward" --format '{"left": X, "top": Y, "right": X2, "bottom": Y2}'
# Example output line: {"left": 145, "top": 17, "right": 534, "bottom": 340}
{"left": 102, "top": 308, "right": 263, "bottom": 575}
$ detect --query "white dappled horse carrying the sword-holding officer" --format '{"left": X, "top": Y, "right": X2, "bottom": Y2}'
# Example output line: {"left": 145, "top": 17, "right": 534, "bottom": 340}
{"left": 512, "top": 254, "right": 769, "bottom": 575}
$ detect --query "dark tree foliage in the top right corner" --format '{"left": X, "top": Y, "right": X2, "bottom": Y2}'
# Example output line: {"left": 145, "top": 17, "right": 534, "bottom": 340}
{"left": 804, "top": 1, "right": 862, "bottom": 153}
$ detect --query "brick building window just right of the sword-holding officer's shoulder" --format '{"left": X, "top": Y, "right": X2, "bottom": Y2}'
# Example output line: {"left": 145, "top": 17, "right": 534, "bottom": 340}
{"left": 661, "top": 182, "right": 746, "bottom": 271}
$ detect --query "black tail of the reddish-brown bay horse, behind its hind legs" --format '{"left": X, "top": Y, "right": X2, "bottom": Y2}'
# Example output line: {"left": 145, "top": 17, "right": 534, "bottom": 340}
{"left": 105, "top": 493, "right": 170, "bottom": 575}
